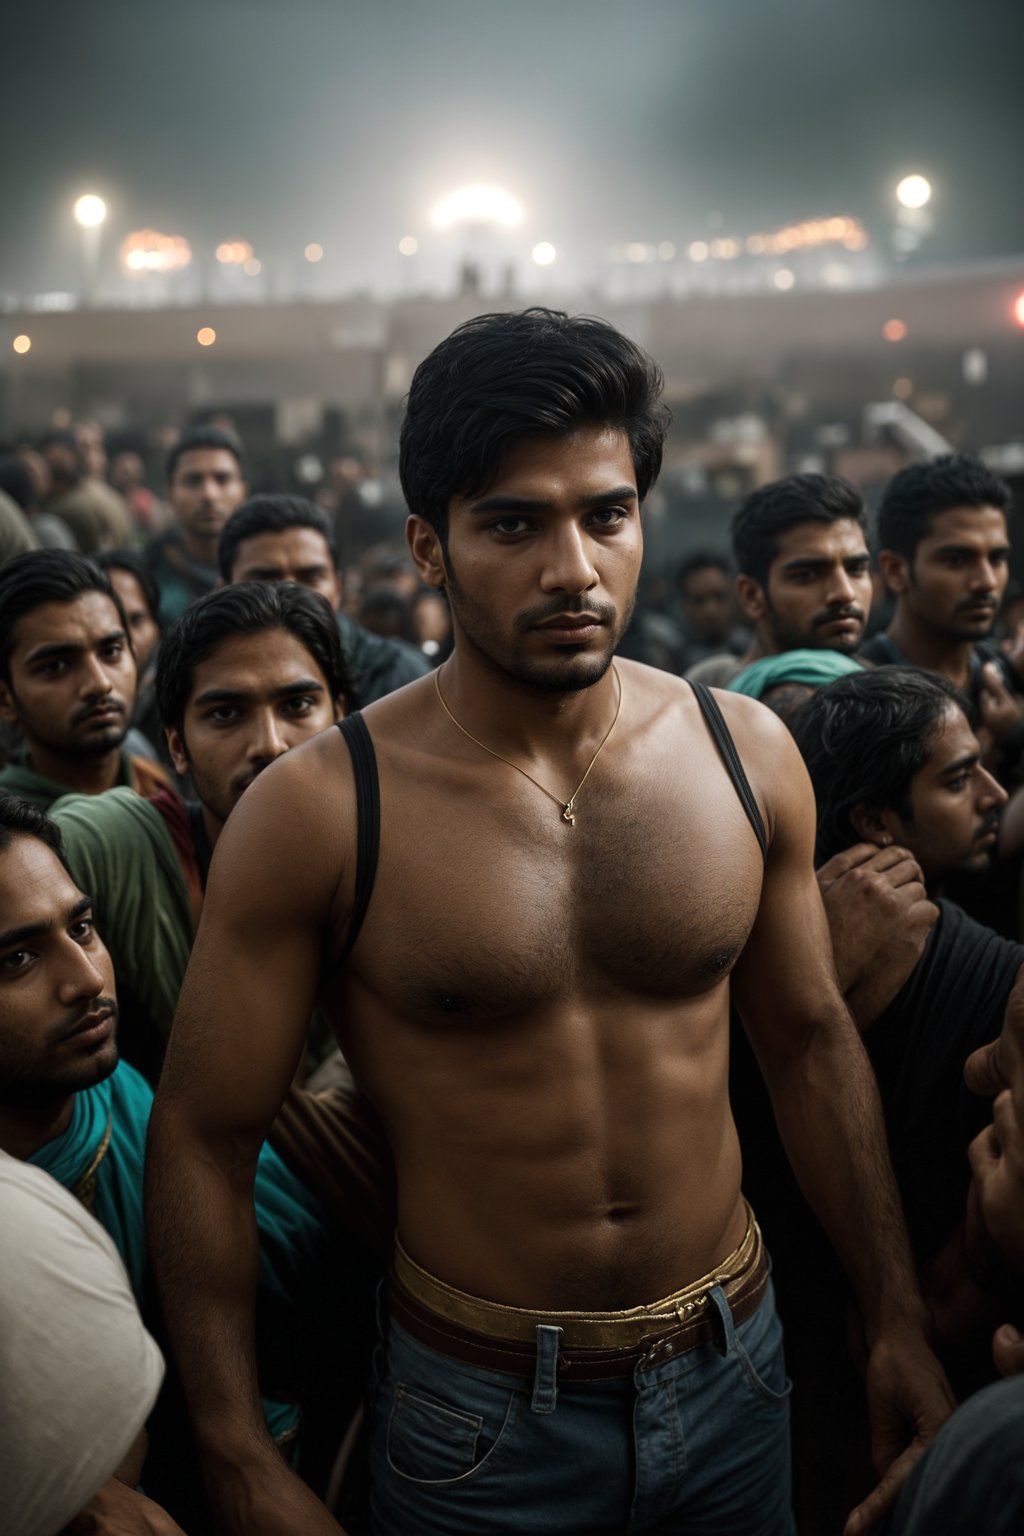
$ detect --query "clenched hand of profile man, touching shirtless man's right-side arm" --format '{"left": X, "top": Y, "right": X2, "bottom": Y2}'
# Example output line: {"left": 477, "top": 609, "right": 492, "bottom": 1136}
{"left": 817, "top": 843, "right": 938, "bottom": 1029}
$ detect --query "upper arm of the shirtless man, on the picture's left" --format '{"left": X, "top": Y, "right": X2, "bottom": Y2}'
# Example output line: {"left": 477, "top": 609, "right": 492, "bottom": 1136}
{"left": 161, "top": 763, "right": 348, "bottom": 1137}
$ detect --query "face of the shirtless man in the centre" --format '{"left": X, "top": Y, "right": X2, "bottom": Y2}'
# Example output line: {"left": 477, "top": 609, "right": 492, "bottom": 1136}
{"left": 410, "top": 427, "right": 643, "bottom": 693}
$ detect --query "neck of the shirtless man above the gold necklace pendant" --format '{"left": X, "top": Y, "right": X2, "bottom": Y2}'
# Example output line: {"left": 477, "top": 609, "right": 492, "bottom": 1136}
{"left": 438, "top": 644, "right": 619, "bottom": 766}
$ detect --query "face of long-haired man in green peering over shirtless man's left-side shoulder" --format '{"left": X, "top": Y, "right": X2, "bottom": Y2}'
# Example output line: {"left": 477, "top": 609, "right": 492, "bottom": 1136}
{"left": 167, "top": 630, "right": 339, "bottom": 822}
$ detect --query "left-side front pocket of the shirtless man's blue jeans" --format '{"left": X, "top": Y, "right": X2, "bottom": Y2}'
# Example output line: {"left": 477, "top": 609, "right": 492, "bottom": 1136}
{"left": 387, "top": 1382, "right": 516, "bottom": 1485}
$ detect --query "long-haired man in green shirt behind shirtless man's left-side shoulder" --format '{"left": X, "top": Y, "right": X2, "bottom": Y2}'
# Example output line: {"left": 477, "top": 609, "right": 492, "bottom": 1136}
{"left": 54, "top": 582, "right": 348, "bottom": 1081}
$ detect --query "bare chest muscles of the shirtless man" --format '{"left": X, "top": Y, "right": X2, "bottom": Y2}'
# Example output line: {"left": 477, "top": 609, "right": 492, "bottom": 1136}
{"left": 342, "top": 765, "right": 761, "bottom": 1023}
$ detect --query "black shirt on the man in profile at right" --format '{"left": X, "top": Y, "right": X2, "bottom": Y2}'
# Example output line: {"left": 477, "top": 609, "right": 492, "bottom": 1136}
{"left": 864, "top": 900, "right": 1024, "bottom": 1260}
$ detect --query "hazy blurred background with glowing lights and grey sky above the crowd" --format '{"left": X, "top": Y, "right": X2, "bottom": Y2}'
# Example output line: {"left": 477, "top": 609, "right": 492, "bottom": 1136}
{"left": 0, "top": 0, "right": 1024, "bottom": 574}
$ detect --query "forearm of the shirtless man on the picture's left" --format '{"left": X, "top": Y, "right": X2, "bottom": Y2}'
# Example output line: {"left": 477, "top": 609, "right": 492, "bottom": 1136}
{"left": 146, "top": 1098, "right": 276, "bottom": 1482}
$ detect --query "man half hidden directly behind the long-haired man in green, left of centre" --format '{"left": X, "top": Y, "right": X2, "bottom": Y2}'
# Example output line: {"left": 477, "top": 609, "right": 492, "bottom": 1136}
{"left": 216, "top": 496, "right": 430, "bottom": 705}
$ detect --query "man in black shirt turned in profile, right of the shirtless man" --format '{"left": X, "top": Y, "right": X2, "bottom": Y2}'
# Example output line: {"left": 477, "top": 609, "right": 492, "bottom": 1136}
{"left": 792, "top": 667, "right": 1024, "bottom": 1258}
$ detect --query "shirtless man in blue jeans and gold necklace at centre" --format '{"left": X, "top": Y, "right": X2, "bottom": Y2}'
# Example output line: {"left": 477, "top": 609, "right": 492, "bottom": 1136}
{"left": 149, "top": 310, "right": 952, "bottom": 1536}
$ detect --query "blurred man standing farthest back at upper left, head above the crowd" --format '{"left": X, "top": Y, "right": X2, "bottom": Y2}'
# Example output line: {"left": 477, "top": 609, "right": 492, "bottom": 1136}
{"left": 146, "top": 427, "right": 249, "bottom": 624}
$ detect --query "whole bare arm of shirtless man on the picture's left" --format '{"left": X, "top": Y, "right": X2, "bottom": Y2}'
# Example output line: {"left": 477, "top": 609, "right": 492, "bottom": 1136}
{"left": 146, "top": 733, "right": 353, "bottom": 1536}
